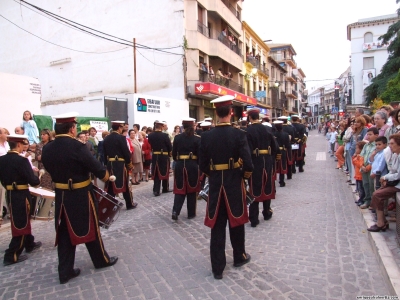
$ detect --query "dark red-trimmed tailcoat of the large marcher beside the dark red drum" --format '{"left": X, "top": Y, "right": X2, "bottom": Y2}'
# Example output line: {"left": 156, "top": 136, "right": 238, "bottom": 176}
{"left": 42, "top": 134, "right": 109, "bottom": 245}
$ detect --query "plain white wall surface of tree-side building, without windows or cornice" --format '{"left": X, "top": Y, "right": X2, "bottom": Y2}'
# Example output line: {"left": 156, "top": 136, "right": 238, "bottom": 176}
{"left": 351, "top": 19, "right": 391, "bottom": 104}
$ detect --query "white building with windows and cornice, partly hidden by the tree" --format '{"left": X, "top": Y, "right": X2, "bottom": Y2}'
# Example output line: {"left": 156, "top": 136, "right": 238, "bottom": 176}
{"left": 347, "top": 14, "right": 399, "bottom": 105}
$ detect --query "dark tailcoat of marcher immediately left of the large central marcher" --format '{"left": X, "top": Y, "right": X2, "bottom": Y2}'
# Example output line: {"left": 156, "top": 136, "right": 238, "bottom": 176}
{"left": 172, "top": 133, "right": 201, "bottom": 195}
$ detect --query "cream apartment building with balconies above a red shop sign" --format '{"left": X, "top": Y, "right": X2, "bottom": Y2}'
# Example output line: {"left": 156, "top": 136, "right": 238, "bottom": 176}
{"left": 185, "top": 0, "right": 257, "bottom": 119}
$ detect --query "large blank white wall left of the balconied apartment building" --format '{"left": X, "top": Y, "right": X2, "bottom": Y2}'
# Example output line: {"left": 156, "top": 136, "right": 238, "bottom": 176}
{"left": 0, "top": 0, "right": 184, "bottom": 103}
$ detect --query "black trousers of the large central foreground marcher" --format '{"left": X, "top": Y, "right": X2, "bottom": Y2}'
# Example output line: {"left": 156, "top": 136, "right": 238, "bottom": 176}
{"left": 210, "top": 199, "right": 246, "bottom": 274}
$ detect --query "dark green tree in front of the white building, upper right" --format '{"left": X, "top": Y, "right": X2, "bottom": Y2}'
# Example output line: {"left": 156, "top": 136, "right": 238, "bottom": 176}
{"left": 365, "top": 0, "right": 400, "bottom": 104}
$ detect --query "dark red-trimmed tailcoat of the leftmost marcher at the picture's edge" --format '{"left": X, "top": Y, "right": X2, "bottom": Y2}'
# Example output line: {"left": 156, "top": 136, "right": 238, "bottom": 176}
{"left": 0, "top": 151, "right": 40, "bottom": 237}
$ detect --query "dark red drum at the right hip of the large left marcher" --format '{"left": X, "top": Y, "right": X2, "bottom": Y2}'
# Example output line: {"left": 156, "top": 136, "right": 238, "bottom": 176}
{"left": 93, "top": 186, "right": 124, "bottom": 229}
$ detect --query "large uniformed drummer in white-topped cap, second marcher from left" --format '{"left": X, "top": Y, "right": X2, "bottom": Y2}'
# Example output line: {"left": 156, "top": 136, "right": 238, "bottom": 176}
{"left": 42, "top": 114, "right": 118, "bottom": 284}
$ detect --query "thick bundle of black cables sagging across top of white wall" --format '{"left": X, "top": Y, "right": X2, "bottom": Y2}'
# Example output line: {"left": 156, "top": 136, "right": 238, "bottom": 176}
{"left": 13, "top": 0, "right": 182, "bottom": 55}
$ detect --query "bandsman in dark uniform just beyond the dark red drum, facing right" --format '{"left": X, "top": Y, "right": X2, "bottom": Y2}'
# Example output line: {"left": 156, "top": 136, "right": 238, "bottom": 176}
{"left": 103, "top": 121, "right": 137, "bottom": 210}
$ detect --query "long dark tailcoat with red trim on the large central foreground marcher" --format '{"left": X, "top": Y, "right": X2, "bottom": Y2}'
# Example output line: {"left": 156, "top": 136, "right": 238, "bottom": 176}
{"left": 199, "top": 123, "right": 253, "bottom": 228}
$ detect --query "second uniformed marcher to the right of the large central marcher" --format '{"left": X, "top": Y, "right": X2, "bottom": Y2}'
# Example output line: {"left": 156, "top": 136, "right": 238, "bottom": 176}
{"left": 274, "top": 121, "right": 292, "bottom": 187}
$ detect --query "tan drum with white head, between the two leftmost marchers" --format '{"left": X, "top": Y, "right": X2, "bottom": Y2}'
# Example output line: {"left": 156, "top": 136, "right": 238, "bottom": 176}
{"left": 29, "top": 186, "right": 55, "bottom": 221}
